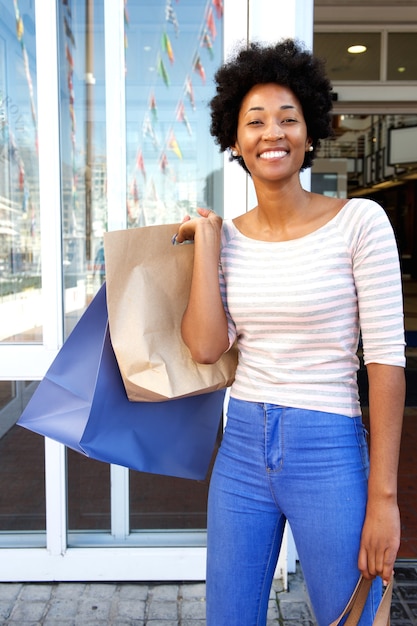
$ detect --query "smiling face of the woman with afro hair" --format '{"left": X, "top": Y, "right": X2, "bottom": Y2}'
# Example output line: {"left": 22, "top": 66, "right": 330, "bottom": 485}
{"left": 232, "top": 83, "right": 312, "bottom": 180}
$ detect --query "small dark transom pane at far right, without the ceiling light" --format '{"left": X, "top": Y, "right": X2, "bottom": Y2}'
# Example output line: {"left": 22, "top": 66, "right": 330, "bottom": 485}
{"left": 387, "top": 33, "right": 417, "bottom": 80}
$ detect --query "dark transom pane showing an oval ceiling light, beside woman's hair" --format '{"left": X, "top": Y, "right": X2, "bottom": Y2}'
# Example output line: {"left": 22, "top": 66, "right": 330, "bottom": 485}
{"left": 313, "top": 33, "right": 381, "bottom": 81}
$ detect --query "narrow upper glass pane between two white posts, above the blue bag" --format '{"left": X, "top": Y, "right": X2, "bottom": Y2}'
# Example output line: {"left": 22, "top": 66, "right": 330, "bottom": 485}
{"left": 58, "top": 0, "right": 107, "bottom": 336}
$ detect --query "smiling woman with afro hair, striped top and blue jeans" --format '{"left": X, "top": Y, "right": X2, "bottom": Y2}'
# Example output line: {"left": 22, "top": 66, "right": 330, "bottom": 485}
{"left": 177, "top": 40, "right": 405, "bottom": 626}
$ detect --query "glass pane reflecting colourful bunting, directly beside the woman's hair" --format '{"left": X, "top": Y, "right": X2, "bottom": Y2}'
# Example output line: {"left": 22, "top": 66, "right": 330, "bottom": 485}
{"left": 126, "top": 0, "right": 223, "bottom": 226}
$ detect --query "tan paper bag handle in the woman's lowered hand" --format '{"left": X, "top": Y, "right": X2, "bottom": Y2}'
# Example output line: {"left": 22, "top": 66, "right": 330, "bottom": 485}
{"left": 330, "top": 576, "right": 393, "bottom": 626}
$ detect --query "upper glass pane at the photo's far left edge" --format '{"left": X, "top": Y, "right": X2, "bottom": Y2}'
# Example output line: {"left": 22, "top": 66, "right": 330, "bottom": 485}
{"left": 0, "top": 0, "right": 42, "bottom": 343}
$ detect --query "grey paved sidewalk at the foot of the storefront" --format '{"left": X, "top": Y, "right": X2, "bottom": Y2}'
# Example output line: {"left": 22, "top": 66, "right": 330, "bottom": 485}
{"left": 0, "top": 561, "right": 417, "bottom": 626}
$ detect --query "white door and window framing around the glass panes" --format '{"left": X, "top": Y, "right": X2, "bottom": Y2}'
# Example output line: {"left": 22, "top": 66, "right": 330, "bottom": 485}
{"left": 0, "top": 0, "right": 313, "bottom": 581}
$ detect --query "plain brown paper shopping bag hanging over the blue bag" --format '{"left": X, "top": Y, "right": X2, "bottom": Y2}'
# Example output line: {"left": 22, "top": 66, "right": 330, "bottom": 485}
{"left": 104, "top": 224, "right": 237, "bottom": 402}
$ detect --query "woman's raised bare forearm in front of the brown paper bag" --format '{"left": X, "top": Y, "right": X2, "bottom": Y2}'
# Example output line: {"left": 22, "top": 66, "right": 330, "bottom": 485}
{"left": 181, "top": 220, "right": 229, "bottom": 363}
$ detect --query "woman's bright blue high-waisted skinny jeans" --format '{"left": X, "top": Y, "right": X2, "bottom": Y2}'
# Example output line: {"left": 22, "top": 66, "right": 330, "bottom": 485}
{"left": 206, "top": 398, "right": 382, "bottom": 626}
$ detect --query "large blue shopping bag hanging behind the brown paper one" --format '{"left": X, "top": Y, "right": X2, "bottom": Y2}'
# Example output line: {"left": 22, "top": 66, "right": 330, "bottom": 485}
{"left": 18, "top": 284, "right": 224, "bottom": 480}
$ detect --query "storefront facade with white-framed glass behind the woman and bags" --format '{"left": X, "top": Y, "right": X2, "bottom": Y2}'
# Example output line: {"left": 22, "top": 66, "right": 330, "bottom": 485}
{"left": 0, "top": 0, "right": 417, "bottom": 581}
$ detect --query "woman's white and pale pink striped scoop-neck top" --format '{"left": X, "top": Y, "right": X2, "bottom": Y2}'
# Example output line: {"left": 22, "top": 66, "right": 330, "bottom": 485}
{"left": 220, "top": 199, "right": 405, "bottom": 417}
